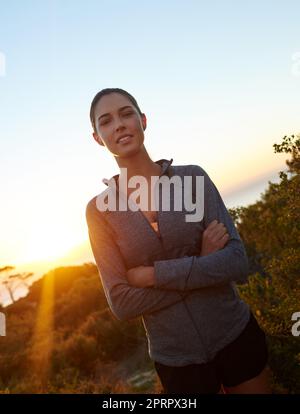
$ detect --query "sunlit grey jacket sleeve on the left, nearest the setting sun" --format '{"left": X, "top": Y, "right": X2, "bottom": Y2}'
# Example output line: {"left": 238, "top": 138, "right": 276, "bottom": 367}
{"left": 86, "top": 199, "right": 186, "bottom": 320}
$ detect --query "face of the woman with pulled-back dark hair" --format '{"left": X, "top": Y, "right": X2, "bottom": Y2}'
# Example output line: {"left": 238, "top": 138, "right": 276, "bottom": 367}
{"left": 93, "top": 93, "right": 147, "bottom": 157}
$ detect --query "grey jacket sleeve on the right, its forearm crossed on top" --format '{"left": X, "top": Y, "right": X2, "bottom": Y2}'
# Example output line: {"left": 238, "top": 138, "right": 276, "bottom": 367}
{"left": 154, "top": 166, "right": 249, "bottom": 291}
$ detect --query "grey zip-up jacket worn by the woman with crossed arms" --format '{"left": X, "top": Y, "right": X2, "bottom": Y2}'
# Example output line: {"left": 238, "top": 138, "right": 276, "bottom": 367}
{"left": 86, "top": 159, "right": 250, "bottom": 366}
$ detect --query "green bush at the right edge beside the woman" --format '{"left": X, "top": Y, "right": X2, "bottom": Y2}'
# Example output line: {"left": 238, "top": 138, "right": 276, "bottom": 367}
{"left": 231, "top": 135, "right": 300, "bottom": 393}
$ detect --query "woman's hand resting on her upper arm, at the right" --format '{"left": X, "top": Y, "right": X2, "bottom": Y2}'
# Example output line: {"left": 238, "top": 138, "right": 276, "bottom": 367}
{"left": 200, "top": 220, "right": 229, "bottom": 256}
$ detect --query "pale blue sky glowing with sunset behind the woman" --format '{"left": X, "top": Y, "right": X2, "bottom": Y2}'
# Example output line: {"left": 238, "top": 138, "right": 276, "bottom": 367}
{"left": 0, "top": 0, "right": 300, "bottom": 267}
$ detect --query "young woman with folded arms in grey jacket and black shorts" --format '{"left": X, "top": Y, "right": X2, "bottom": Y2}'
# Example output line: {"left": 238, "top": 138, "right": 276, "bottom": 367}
{"left": 86, "top": 88, "right": 270, "bottom": 393}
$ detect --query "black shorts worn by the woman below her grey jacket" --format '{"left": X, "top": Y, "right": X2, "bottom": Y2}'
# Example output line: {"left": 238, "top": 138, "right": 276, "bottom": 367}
{"left": 154, "top": 313, "right": 268, "bottom": 394}
